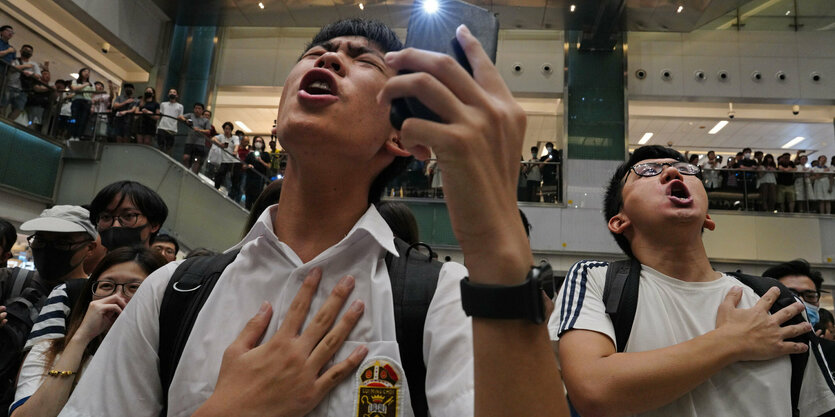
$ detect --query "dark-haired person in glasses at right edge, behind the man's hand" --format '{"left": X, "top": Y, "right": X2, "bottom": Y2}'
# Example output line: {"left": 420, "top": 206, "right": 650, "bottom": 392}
{"left": 763, "top": 259, "right": 835, "bottom": 364}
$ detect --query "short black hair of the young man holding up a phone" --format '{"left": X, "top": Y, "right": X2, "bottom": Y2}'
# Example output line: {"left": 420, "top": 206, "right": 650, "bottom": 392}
{"left": 302, "top": 18, "right": 414, "bottom": 204}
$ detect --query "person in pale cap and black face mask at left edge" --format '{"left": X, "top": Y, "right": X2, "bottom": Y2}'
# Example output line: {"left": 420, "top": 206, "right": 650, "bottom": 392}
{"left": 0, "top": 206, "right": 98, "bottom": 407}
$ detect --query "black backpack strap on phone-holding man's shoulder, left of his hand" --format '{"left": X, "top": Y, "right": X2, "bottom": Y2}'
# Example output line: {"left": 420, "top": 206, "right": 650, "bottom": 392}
{"left": 157, "top": 250, "right": 239, "bottom": 416}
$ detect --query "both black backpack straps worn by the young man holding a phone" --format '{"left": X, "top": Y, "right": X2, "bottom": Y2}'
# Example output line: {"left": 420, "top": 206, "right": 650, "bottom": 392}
{"left": 158, "top": 238, "right": 443, "bottom": 417}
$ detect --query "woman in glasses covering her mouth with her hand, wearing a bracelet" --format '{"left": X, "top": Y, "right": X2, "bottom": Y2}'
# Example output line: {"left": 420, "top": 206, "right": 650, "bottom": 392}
{"left": 9, "top": 247, "right": 165, "bottom": 417}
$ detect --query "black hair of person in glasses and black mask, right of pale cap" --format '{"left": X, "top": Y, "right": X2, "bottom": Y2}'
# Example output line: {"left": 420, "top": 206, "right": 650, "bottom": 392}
{"left": 90, "top": 181, "right": 168, "bottom": 240}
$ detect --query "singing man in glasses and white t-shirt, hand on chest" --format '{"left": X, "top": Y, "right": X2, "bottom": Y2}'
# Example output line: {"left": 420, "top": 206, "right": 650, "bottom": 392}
{"left": 549, "top": 146, "right": 835, "bottom": 416}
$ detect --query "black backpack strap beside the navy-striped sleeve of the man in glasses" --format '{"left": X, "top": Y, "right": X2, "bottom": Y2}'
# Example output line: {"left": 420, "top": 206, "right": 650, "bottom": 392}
{"left": 603, "top": 259, "right": 641, "bottom": 352}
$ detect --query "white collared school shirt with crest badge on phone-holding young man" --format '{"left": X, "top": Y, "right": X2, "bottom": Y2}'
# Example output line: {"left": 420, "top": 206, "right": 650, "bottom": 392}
{"left": 60, "top": 205, "right": 474, "bottom": 417}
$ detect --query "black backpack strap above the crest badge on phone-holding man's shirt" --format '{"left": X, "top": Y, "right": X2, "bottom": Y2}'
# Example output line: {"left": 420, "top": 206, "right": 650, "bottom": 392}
{"left": 386, "top": 238, "right": 443, "bottom": 417}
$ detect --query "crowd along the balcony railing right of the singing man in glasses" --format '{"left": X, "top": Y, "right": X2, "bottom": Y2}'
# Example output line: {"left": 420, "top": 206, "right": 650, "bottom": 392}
{"left": 689, "top": 148, "right": 835, "bottom": 214}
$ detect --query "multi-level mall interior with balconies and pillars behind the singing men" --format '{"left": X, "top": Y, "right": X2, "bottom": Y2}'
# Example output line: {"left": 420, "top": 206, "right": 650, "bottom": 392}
{"left": 0, "top": 0, "right": 835, "bottom": 309}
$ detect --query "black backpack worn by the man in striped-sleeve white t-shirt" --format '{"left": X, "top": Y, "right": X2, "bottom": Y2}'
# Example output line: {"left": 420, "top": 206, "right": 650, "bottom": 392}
{"left": 603, "top": 259, "right": 824, "bottom": 416}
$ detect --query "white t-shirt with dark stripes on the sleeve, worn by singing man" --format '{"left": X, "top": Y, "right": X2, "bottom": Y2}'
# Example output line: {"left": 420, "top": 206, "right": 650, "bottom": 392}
{"left": 548, "top": 261, "right": 835, "bottom": 417}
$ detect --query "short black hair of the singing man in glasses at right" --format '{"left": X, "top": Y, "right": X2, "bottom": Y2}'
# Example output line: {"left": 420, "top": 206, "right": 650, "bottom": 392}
{"left": 603, "top": 145, "right": 687, "bottom": 258}
